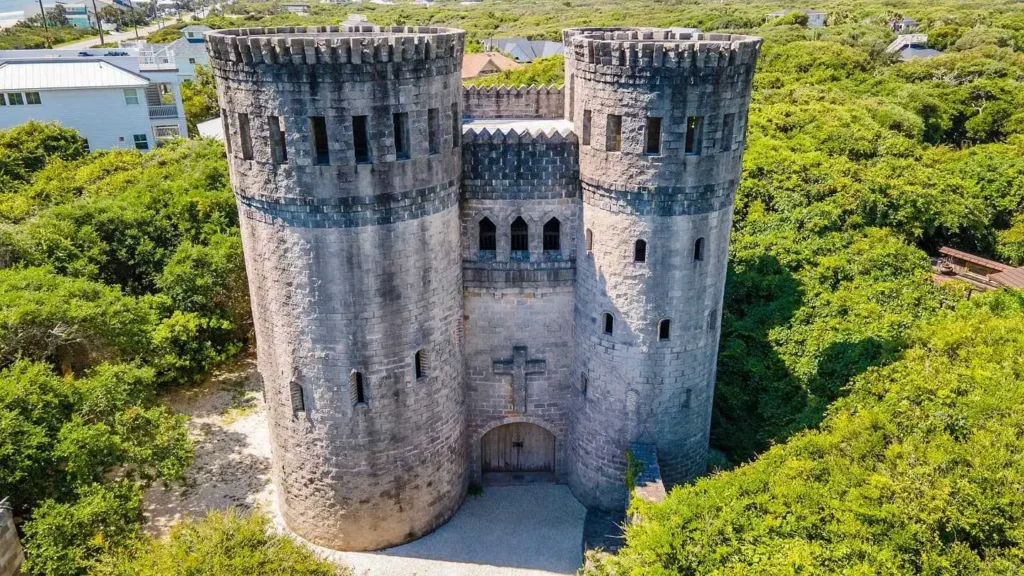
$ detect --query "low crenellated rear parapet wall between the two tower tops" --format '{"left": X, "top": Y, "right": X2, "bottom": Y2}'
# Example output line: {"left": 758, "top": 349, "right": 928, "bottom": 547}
{"left": 462, "top": 86, "right": 565, "bottom": 118}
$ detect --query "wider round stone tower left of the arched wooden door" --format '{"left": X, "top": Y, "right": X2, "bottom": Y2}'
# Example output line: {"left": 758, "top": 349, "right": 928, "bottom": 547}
{"left": 208, "top": 26, "right": 467, "bottom": 549}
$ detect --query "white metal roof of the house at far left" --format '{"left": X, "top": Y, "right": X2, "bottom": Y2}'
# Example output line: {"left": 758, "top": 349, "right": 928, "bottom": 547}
{"left": 0, "top": 60, "right": 150, "bottom": 90}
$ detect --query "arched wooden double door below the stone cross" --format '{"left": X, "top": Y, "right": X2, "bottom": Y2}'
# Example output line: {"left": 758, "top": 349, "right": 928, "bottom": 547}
{"left": 480, "top": 422, "right": 555, "bottom": 485}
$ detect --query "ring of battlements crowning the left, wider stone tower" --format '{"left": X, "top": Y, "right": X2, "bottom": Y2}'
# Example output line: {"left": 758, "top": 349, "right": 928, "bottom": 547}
{"left": 206, "top": 26, "right": 466, "bottom": 65}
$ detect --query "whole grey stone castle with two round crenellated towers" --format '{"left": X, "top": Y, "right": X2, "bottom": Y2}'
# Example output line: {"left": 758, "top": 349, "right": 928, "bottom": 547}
{"left": 208, "top": 25, "right": 761, "bottom": 549}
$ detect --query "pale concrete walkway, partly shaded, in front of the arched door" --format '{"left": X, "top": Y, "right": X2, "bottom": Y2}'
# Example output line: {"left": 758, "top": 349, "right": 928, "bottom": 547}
{"left": 327, "top": 484, "right": 587, "bottom": 576}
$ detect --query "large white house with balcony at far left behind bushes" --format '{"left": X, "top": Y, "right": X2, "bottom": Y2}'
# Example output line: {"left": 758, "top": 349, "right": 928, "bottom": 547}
{"left": 0, "top": 49, "right": 186, "bottom": 150}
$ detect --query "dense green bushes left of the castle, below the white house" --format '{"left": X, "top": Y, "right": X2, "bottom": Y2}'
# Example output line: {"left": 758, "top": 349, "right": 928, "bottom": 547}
{"left": 0, "top": 123, "right": 250, "bottom": 575}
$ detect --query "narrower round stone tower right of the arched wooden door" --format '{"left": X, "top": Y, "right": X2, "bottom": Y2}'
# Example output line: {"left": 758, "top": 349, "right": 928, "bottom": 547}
{"left": 565, "top": 30, "right": 761, "bottom": 508}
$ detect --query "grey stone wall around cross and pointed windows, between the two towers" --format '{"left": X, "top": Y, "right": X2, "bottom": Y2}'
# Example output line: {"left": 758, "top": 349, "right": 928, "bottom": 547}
{"left": 462, "top": 124, "right": 580, "bottom": 482}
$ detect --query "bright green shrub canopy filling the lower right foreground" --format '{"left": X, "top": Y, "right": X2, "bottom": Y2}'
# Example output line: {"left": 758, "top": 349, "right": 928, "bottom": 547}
{"left": 591, "top": 291, "right": 1024, "bottom": 576}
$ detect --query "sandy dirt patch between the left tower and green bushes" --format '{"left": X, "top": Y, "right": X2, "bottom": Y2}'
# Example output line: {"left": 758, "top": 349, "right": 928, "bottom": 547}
{"left": 144, "top": 357, "right": 274, "bottom": 536}
